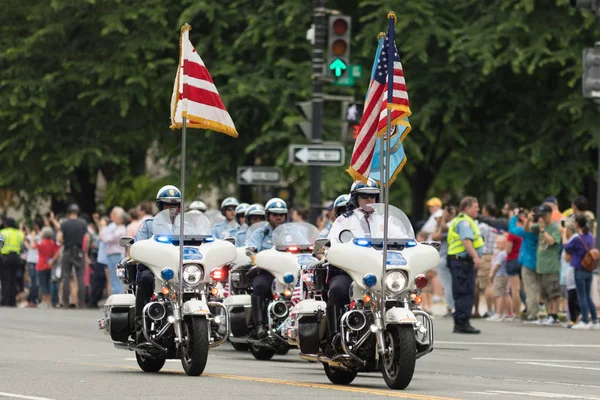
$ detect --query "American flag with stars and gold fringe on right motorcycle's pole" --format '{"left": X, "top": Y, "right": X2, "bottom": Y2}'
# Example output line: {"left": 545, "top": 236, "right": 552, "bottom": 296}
{"left": 348, "top": 14, "right": 410, "bottom": 180}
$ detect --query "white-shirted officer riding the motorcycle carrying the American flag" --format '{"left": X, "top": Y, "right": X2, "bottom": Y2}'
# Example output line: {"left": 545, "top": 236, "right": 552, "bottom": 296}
{"left": 326, "top": 178, "right": 379, "bottom": 340}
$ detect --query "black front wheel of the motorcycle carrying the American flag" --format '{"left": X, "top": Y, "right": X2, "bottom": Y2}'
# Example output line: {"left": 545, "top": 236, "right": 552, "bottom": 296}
{"left": 380, "top": 325, "right": 417, "bottom": 390}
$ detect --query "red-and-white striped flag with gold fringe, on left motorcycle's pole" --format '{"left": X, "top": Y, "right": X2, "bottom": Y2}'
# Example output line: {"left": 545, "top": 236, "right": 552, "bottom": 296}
{"left": 171, "top": 24, "right": 238, "bottom": 137}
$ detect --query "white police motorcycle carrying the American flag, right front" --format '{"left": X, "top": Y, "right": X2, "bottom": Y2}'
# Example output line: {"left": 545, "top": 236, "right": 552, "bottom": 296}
{"left": 288, "top": 204, "right": 440, "bottom": 389}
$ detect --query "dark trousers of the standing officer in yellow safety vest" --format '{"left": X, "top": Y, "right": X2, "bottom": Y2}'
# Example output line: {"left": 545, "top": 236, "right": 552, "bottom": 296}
{"left": 448, "top": 256, "right": 475, "bottom": 325}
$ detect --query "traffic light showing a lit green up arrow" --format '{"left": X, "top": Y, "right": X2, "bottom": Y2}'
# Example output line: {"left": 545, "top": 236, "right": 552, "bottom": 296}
{"left": 327, "top": 15, "right": 352, "bottom": 79}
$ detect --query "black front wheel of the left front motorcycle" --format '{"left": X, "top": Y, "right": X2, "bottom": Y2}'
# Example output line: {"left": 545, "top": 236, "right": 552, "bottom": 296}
{"left": 181, "top": 317, "right": 209, "bottom": 376}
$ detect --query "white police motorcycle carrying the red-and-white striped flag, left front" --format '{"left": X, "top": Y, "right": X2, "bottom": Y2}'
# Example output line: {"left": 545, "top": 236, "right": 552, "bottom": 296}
{"left": 98, "top": 209, "right": 236, "bottom": 376}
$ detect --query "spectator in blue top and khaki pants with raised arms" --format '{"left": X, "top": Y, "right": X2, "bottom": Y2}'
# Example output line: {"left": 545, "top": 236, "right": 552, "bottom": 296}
{"left": 509, "top": 208, "right": 539, "bottom": 323}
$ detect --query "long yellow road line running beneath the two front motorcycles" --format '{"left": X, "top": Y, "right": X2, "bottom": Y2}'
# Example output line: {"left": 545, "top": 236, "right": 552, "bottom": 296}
{"left": 57, "top": 361, "right": 459, "bottom": 400}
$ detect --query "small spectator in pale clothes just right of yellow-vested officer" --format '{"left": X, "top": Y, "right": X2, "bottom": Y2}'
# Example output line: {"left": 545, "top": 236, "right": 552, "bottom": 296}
{"left": 487, "top": 235, "right": 514, "bottom": 322}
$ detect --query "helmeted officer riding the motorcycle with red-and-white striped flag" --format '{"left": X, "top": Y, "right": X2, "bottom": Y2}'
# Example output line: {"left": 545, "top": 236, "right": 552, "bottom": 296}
{"left": 134, "top": 185, "right": 181, "bottom": 344}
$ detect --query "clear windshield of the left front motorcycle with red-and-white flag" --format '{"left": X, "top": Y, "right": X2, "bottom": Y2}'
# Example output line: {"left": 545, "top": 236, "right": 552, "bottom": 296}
{"left": 152, "top": 209, "right": 211, "bottom": 237}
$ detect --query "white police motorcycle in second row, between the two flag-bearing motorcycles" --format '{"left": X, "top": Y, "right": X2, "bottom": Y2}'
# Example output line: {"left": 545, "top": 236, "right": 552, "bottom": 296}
{"left": 224, "top": 222, "right": 319, "bottom": 360}
